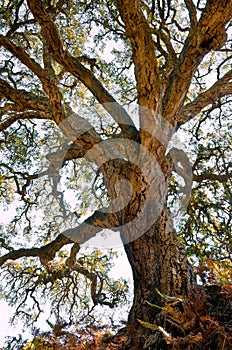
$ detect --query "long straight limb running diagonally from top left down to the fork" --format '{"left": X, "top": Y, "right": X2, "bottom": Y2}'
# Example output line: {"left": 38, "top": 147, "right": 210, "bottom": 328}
{"left": 28, "top": 0, "right": 138, "bottom": 139}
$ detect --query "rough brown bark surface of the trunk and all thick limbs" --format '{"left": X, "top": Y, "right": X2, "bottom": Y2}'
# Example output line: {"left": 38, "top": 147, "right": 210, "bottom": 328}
{"left": 0, "top": 0, "right": 232, "bottom": 350}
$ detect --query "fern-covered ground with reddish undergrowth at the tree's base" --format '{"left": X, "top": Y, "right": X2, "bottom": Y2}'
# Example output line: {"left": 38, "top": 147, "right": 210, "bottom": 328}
{"left": 21, "top": 284, "right": 232, "bottom": 350}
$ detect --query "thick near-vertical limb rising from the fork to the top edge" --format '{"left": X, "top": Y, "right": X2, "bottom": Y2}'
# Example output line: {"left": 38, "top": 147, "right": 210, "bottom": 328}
{"left": 116, "top": 0, "right": 160, "bottom": 110}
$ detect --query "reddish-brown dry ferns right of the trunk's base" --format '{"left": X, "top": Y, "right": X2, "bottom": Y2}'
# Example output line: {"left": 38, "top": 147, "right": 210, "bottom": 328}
{"left": 139, "top": 285, "right": 232, "bottom": 350}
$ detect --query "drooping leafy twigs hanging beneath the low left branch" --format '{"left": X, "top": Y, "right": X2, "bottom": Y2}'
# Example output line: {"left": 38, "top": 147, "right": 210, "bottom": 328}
{"left": 1, "top": 250, "right": 128, "bottom": 326}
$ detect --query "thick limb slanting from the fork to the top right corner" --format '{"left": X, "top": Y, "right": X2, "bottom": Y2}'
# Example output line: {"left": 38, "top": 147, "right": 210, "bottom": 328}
{"left": 163, "top": 0, "right": 232, "bottom": 124}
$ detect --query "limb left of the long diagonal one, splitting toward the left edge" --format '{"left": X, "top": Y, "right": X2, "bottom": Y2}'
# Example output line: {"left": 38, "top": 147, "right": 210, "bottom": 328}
{"left": 0, "top": 35, "right": 101, "bottom": 149}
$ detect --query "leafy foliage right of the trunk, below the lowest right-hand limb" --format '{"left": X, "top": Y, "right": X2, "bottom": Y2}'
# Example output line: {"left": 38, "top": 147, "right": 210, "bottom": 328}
{"left": 169, "top": 104, "right": 232, "bottom": 283}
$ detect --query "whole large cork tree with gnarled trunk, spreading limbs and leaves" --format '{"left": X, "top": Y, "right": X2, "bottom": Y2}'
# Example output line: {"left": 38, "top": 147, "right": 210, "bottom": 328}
{"left": 0, "top": 0, "right": 232, "bottom": 349}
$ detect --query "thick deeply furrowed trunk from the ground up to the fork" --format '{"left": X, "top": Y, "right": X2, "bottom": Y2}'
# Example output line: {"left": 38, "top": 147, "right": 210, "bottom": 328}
{"left": 102, "top": 143, "right": 189, "bottom": 350}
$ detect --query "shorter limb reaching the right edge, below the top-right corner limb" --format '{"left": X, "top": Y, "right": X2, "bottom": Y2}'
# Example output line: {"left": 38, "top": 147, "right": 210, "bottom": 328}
{"left": 178, "top": 70, "right": 232, "bottom": 125}
